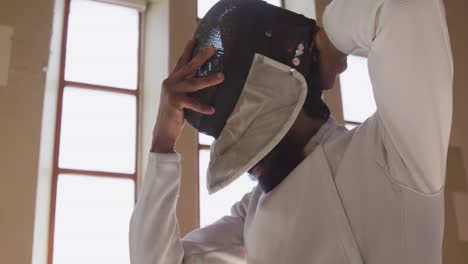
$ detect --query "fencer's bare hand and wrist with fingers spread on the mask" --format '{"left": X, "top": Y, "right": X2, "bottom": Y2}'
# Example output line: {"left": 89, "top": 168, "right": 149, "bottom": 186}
{"left": 151, "top": 39, "right": 224, "bottom": 153}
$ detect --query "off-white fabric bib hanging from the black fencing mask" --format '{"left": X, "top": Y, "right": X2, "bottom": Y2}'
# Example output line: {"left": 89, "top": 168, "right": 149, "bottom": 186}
{"left": 206, "top": 54, "right": 307, "bottom": 193}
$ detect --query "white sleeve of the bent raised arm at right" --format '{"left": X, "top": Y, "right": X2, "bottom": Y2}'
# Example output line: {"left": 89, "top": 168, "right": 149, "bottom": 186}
{"left": 323, "top": 0, "right": 453, "bottom": 193}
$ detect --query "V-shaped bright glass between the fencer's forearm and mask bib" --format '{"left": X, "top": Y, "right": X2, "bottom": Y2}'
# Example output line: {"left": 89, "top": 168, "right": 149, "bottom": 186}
{"left": 199, "top": 150, "right": 257, "bottom": 227}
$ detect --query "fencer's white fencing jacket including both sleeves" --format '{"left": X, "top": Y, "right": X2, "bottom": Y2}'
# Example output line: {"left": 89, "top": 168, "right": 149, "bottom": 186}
{"left": 130, "top": 0, "right": 453, "bottom": 264}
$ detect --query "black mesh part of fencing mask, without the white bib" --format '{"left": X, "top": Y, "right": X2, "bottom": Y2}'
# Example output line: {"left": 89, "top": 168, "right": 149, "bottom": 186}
{"left": 184, "top": 0, "right": 330, "bottom": 138}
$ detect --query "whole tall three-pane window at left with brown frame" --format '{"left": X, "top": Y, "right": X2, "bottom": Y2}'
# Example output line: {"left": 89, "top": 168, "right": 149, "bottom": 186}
{"left": 49, "top": 0, "right": 141, "bottom": 264}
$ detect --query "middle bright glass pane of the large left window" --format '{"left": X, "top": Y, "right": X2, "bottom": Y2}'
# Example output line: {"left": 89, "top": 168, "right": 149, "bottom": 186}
{"left": 59, "top": 87, "right": 136, "bottom": 173}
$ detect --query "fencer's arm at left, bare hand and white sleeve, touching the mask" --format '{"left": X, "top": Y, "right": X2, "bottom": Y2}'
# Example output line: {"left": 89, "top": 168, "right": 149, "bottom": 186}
{"left": 130, "top": 37, "right": 249, "bottom": 264}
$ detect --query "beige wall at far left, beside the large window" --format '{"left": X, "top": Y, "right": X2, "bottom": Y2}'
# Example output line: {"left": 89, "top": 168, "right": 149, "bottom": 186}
{"left": 0, "top": 0, "right": 54, "bottom": 264}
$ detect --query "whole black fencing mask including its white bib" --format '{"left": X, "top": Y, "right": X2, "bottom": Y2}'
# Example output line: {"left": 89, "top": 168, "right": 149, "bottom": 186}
{"left": 185, "top": 0, "right": 329, "bottom": 193}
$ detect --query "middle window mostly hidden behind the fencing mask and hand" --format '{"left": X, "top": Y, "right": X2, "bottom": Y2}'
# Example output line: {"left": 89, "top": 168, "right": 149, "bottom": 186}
{"left": 198, "top": 0, "right": 282, "bottom": 227}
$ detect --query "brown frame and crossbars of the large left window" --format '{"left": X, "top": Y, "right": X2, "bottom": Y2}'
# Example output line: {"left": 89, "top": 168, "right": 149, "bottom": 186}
{"left": 47, "top": 0, "right": 144, "bottom": 264}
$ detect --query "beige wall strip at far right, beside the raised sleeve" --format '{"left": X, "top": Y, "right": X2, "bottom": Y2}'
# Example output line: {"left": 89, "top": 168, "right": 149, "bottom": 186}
{"left": 444, "top": 0, "right": 468, "bottom": 264}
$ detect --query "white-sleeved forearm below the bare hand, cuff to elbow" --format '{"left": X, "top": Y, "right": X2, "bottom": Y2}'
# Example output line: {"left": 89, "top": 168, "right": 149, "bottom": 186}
{"left": 130, "top": 153, "right": 184, "bottom": 264}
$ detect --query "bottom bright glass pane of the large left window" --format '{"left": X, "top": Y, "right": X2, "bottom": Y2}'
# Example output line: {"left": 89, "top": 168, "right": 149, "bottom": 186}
{"left": 53, "top": 175, "right": 135, "bottom": 264}
